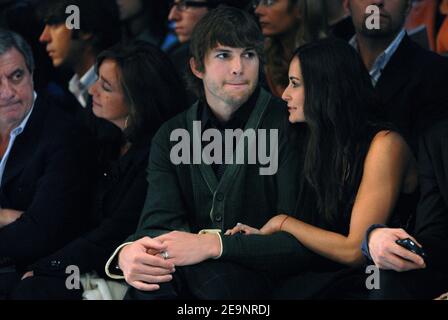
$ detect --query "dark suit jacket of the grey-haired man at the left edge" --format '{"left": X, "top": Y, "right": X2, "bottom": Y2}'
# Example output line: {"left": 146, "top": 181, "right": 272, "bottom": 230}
{"left": 0, "top": 97, "right": 93, "bottom": 268}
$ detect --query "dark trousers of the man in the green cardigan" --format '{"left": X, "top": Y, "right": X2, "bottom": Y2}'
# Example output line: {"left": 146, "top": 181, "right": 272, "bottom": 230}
{"left": 125, "top": 261, "right": 276, "bottom": 300}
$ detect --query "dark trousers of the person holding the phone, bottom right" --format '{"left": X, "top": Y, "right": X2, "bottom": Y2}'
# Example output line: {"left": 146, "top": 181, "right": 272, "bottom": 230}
{"left": 369, "top": 269, "right": 448, "bottom": 300}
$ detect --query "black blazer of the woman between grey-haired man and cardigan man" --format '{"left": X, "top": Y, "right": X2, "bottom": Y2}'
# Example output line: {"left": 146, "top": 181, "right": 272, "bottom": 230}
{"left": 30, "top": 137, "right": 151, "bottom": 276}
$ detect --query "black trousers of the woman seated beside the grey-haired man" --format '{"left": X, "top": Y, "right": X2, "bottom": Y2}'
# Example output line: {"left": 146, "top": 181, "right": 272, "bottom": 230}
{"left": 9, "top": 276, "right": 83, "bottom": 300}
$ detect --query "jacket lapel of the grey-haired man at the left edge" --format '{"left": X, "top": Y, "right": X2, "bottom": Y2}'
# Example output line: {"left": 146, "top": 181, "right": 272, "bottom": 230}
{"left": 2, "top": 98, "right": 44, "bottom": 187}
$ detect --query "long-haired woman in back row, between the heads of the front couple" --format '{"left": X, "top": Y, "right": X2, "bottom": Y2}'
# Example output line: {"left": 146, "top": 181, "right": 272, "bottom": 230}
{"left": 252, "top": 0, "right": 328, "bottom": 97}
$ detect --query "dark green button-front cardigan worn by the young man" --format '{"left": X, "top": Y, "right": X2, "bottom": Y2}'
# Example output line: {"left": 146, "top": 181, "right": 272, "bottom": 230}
{"left": 128, "top": 89, "right": 312, "bottom": 274}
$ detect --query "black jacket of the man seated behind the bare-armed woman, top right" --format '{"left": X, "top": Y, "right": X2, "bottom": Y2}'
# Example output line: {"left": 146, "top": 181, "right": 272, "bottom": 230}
{"left": 375, "top": 36, "right": 448, "bottom": 151}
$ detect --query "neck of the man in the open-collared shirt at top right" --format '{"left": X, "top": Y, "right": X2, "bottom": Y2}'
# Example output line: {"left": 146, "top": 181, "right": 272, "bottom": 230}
{"left": 356, "top": 31, "right": 400, "bottom": 70}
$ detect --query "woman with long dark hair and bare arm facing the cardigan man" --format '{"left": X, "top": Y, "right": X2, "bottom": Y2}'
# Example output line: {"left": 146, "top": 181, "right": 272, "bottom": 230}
{"left": 228, "top": 39, "right": 418, "bottom": 297}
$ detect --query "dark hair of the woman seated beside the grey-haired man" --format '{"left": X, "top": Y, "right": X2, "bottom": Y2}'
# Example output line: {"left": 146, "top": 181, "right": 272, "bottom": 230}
{"left": 96, "top": 41, "right": 187, "bottom": 142}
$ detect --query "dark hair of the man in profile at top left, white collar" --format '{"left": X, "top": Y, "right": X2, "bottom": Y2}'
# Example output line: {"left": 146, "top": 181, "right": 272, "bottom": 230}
{"left": 38, "top": 0, "right": 120, "bottom": 54}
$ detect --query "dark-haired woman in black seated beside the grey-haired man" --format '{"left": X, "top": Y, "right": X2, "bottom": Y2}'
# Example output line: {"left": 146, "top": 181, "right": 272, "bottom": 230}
{"left": 11, "top": 43, "right": 186, "bottom": 299}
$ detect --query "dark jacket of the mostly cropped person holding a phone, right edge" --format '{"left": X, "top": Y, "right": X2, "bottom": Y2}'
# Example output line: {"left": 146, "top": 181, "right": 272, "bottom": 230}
{"left": 415, "top": 120, "right": 448, "bottom": 273}
